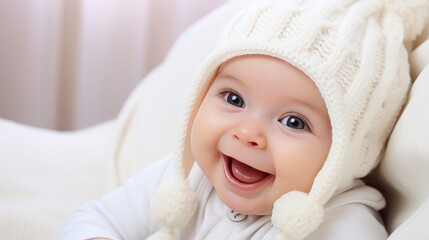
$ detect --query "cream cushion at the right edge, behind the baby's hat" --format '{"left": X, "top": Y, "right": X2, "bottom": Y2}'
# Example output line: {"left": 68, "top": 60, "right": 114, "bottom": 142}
{"left": 376, "top": 65, "right": 429, "bottom": 236}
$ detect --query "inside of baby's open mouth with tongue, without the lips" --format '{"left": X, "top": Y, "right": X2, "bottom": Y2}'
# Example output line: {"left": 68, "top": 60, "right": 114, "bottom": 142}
{"left": 231, "top": 159, "right": 268, "bottom": 184}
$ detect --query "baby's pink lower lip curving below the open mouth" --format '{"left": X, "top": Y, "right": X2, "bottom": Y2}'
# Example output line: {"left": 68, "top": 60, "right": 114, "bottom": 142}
{"left": 223, "top": 155, "right": 274, "bottom": 191}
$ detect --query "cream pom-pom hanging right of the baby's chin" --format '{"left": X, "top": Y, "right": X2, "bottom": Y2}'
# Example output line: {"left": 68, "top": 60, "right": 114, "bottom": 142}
{"left": 271, "top": 191, "right": 323, "bottom": 240}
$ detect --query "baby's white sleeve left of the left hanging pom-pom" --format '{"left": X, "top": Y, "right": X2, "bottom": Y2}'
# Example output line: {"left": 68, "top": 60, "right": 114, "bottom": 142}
{"left": 58, "top": 157, "right": 172, "bottom": 240}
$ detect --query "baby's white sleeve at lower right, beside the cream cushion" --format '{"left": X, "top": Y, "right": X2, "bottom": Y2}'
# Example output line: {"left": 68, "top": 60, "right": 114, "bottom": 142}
{"left": 306, "top": 180, "right": 387, "bottom": 240}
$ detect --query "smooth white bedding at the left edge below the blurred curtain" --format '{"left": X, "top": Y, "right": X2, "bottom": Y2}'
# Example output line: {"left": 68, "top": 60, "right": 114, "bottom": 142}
{"left": 0, "top": 119, "right": 114, "bottom": 240}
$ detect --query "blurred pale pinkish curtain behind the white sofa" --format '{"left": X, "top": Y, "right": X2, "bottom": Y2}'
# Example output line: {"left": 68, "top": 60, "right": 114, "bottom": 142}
{"left": 0, "top": 0, "right": 227, "bottom": 130}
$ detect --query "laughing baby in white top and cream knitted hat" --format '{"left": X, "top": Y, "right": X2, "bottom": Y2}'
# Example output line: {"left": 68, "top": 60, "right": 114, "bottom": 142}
{"left": 60, "top": 0, "right": 429, "bottom": 240}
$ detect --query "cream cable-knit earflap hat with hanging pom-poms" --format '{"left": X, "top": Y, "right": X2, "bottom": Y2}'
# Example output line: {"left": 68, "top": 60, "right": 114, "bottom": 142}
{"left": 150, "top": 0, "right": 429, "bottom": 239}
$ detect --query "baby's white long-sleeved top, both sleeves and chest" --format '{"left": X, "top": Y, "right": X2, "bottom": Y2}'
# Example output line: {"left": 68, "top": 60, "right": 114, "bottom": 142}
{"left": 59, "top": 156, "right": 387, "bottom": 240}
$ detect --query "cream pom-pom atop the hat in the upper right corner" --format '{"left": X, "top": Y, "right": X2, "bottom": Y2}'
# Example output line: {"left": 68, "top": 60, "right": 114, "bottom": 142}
{"left": 384, "top": 0, "right": 429, "bottom": 41}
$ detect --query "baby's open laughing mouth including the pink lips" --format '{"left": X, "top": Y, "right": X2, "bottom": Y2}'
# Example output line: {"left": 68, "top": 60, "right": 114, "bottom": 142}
{"left": 223, "top": 155, "right": 273, "bottom": 191}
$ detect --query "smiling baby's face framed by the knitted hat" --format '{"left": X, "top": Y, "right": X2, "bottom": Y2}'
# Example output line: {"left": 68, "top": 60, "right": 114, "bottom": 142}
{"left": 191, "top": 55, "right": 331, "bottom": 215}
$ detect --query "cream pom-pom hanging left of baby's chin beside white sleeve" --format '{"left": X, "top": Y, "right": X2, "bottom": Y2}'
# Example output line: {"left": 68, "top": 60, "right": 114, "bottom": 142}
{"left": 152, "top": 181, "right": 198, "bottom": 227}
